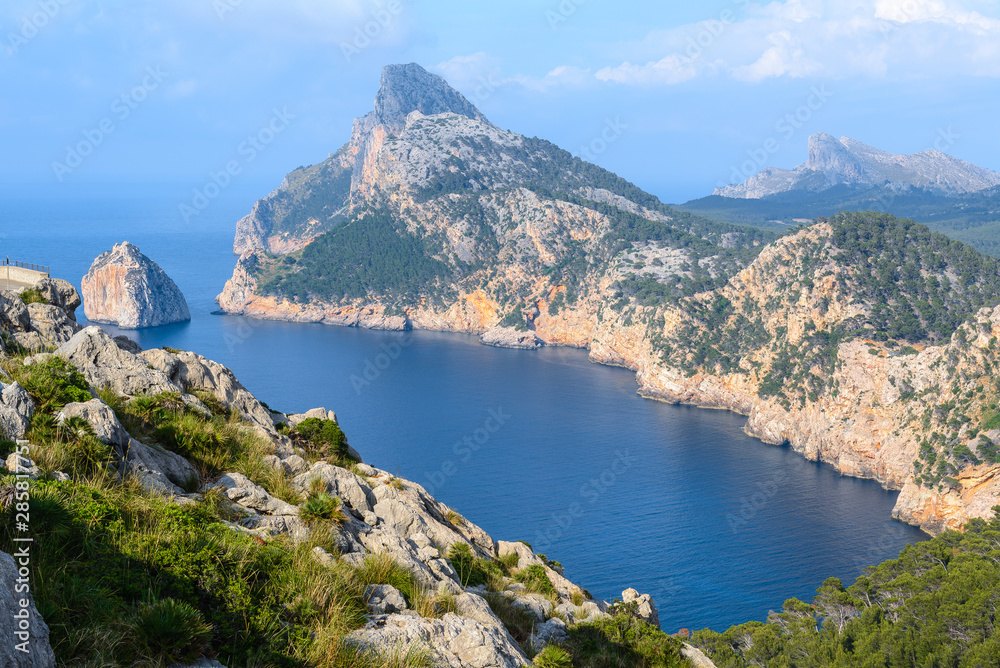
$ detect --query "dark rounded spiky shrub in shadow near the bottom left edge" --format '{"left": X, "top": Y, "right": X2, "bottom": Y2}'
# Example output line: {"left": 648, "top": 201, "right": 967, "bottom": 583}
{"left": 136, "top": 598, "right": 212, "bottom": 663}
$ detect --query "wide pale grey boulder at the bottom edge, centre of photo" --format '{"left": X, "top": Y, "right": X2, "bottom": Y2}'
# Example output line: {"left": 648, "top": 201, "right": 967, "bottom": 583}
{"left": 347, "top": 613, "right": 529, "bottom": 668}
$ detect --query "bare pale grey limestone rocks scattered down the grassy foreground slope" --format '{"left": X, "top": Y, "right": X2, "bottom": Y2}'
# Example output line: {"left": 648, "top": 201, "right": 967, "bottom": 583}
{"left": 0, "top": 298, "right": 680, "bottom": 668}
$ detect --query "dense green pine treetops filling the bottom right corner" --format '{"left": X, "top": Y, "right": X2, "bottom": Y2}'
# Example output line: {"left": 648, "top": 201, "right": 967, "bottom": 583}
{"left": 693, "top": 506, "right": 1000, "bottom": 668}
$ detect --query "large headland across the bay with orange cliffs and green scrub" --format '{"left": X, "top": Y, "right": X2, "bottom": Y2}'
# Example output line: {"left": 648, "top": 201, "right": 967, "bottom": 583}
{"left": 219, "top": 66, "right": 1000, "bottom": 531}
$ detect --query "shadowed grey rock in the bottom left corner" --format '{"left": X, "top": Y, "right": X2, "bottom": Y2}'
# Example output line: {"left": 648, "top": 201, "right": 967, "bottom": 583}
{"left": 0, "top": 552, "right": 56, "bottom": 668}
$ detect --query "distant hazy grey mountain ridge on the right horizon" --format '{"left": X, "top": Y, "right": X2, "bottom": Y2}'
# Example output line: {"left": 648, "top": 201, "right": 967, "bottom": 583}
{"left": 713, "top": 132, "right": 1000, "bottom": 199}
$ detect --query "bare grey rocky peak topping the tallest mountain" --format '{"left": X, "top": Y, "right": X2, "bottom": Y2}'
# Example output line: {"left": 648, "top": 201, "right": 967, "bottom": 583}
{"left": 375, "top": 63, "right": 489, "bottom": 134}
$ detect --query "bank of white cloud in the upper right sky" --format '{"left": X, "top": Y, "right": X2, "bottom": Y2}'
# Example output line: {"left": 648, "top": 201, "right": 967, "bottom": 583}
{"left": 595, "top": 0, "right": 1000, "bottom": 86}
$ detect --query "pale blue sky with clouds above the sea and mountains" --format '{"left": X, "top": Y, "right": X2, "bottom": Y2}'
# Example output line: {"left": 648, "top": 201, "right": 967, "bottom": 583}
{"left": 0, "top": 0, "right": 1000, "bottom": 203}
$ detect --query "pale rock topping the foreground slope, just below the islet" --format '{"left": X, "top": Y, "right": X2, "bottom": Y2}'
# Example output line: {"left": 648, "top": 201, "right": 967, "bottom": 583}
{"left": 56, "top": 326, "right": 181, "bottom": 397}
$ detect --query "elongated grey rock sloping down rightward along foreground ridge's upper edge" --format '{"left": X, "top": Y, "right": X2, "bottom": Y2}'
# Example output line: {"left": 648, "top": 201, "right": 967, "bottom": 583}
{"left": 139, "top": 348, "right": 278, "bottom": 437}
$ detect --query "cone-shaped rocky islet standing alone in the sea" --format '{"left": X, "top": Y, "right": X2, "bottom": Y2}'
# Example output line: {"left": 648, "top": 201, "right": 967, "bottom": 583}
{"left": 82, "top": 241, "right": 191, "bottom": 329}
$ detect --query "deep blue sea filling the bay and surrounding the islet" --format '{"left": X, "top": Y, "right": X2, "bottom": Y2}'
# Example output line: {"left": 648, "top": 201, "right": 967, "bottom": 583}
{"left": 0, "top": 186, "right": 926, "bottom": 632}
